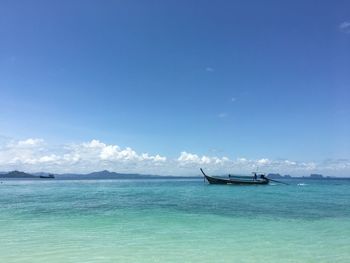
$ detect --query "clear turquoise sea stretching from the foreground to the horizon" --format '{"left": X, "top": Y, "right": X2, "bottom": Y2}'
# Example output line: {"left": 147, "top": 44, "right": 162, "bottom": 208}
{"left": 0, "top": 179, "right": 350, "bottom": 263}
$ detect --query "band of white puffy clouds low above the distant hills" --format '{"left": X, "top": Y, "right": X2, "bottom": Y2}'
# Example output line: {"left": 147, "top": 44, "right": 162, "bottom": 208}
{"left": 0, "top": 138, "right": 350, "bottom": 176}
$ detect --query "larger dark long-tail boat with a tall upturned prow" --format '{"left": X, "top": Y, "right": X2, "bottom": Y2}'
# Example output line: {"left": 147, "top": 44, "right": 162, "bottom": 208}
{"left": 200, "top": 168, "right": 270, "bottom": 185}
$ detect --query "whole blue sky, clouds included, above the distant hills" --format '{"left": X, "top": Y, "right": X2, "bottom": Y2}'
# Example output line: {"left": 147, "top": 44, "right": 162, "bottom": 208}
{"left": 0, "top": 0, "right": 350, "bottom": 176}
